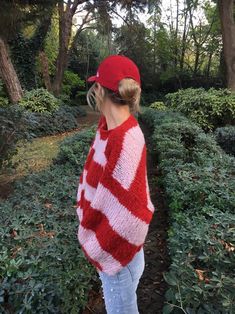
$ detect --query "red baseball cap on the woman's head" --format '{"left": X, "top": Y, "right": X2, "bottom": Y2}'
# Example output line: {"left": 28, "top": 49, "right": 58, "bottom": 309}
{"left": 87, "top": 55, "right": 141, "bottom": 92}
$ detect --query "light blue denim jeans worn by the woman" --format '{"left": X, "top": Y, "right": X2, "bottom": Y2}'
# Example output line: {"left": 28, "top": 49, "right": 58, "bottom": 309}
{"left": 98, "top": 247, "right": 145, "bottom": 314}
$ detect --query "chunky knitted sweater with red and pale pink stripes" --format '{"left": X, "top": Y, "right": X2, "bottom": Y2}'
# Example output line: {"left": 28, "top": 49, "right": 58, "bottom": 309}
{"left": 77, "top": 114, "right": 155, "bottom": 275}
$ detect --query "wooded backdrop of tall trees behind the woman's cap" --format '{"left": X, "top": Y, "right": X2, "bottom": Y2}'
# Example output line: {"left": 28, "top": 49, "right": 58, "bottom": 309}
{"left": 0, "top": 0, "right": 235, "bottom": 102}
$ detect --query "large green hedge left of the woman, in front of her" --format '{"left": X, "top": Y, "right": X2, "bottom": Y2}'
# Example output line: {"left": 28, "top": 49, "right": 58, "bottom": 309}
{"left": 0, "top": 127, "right": 97, "bottom": 314}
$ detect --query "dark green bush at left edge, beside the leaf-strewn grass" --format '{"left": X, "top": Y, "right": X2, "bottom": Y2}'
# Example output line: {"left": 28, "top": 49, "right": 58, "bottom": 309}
{"left": 0, "top": 105, "right": 30, "bottom": 170}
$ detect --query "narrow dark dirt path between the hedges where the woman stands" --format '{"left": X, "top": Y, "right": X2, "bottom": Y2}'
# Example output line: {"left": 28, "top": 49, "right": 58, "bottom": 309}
{"left": 82, "top": 111, "right": 170, "bottom": 314}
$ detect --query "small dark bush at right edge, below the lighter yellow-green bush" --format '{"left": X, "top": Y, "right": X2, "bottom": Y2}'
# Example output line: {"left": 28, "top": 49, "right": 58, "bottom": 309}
{"left": 214, "top": 125, "right": 235, "bottom": 156}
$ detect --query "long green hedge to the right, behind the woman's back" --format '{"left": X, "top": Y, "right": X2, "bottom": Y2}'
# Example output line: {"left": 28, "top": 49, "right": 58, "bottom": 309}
{"left": 141, "top": 108, "right": 235, "bottom": 313}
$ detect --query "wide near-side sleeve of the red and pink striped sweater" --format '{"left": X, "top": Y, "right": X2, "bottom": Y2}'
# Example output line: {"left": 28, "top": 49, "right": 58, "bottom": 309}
{"left": 87, "top": 127, "right": 154, "bottom": 275}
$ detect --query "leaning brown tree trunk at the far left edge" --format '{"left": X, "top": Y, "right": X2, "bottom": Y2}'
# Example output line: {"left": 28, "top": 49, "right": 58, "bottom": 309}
{"left": 0, "top": 37, "right": 23, "bottom": 104}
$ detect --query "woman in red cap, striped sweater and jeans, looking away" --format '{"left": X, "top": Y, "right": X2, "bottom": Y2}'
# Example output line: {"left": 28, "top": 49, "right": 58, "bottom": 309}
{"left": 77, "top": 55, "right": 155, "bottom": 314}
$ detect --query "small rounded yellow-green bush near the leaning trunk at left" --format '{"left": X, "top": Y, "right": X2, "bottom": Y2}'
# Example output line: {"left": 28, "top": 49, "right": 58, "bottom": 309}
{"left": 20, "top": 88, "right": 60, "bottom": 113}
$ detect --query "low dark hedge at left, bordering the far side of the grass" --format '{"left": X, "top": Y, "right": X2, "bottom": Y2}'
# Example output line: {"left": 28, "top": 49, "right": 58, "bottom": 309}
{"left": 0, "top": 105, "right": 86, "bottom": 170}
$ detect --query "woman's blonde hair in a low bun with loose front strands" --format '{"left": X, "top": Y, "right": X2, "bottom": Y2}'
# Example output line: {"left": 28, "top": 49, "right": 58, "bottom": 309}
{"left": 87, "top": 78, "right": 141, "bottom": 114}
